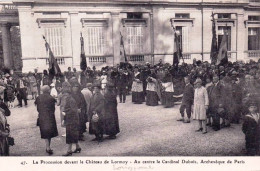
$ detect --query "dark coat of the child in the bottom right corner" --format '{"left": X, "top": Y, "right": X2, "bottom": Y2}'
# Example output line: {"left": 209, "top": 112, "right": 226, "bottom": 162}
{"left": 242, "top": 114, "right": 260, "bottom": 149}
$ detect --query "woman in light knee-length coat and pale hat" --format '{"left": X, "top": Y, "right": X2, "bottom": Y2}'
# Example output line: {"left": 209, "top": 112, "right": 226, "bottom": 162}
{"left": 193, "top": 79, "right": 209, "bottom": 134}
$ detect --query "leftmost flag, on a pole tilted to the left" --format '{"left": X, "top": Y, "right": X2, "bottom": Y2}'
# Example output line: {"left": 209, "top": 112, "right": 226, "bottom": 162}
{"left": 43, "top": 36, "right": 61, "bottom": 79}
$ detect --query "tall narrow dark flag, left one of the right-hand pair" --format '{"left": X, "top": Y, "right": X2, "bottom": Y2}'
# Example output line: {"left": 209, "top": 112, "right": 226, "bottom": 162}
{"left": 210, "top": 13, "right": 218, "bottom": 64}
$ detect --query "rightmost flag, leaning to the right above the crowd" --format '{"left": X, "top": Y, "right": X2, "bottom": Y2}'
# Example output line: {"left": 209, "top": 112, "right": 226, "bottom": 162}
{"left": 217, "top": 31, "right": 228, "bottom": 65}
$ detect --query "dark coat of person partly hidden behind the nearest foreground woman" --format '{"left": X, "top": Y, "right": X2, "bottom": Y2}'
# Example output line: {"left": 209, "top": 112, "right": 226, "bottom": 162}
{"left": 72, "top": 91, "right": 88, "bottom": 134}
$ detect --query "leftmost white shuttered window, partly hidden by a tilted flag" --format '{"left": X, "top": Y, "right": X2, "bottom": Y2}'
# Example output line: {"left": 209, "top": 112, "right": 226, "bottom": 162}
{"left": 44, "top": 26, "right": 64, "bottom": 56}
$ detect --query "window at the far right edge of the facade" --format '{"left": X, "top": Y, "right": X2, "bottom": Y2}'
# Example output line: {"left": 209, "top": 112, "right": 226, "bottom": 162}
{"left": 248, "top": 27, "right": 260, "bottom": 50}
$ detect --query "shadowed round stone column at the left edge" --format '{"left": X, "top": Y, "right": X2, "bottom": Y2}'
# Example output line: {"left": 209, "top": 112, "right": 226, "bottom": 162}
{"left": 1, "top": 24, "right": 13, "bottom": 69}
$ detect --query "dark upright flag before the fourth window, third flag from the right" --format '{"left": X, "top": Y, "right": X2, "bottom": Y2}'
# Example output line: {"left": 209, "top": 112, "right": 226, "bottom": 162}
{"left": 173, "top": 29, "right": 184, "bottom": 68}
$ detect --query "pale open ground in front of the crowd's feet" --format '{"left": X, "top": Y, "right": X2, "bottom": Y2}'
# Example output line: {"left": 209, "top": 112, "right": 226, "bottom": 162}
{"left": 8, "top": 96, "right": 245, "bottom": 156}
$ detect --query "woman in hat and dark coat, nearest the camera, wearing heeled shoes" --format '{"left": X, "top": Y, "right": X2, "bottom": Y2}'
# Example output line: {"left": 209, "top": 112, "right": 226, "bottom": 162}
{"left": 62, "top": 81, "right": 81, "bottom": 156}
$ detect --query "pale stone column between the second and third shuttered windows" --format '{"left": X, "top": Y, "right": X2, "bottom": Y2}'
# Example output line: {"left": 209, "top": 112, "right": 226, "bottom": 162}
{"left": 111, "top": 13, "right": 121, "bottom": 66}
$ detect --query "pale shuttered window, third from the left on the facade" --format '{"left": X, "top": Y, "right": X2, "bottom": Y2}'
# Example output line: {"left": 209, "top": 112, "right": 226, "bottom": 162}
{"left": 127, "top": 26, "right": 144, "bottom": 54}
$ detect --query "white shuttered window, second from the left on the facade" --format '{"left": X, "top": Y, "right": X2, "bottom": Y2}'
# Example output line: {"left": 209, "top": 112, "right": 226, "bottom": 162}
{"left": 84, "top": 26, "right": 106, "bottom": 55}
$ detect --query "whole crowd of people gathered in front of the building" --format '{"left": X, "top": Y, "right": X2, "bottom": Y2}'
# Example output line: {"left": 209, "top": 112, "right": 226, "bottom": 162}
{"left": 0, "top": 59, "right": 260, "bottom": 156}
